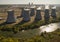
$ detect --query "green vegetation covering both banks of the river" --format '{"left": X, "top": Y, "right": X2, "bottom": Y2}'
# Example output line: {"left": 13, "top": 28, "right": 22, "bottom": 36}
{"left": 0, "top": 13, "right": 60, "bottom": 42}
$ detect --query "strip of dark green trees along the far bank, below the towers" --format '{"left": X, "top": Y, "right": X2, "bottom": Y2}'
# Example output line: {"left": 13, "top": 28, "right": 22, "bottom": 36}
{"left": 0, "top": 17, "right": 60, "bottom": 33}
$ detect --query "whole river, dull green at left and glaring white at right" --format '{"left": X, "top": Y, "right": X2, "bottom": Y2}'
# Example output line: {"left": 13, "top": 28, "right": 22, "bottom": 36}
{"left": 0, "top": 23, "right": 60, "bottom": 38}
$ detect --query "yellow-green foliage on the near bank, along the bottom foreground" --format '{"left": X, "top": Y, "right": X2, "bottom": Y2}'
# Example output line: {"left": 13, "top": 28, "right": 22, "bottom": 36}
{"left": 0, "top": 29, "right": 60, "bottom": 42}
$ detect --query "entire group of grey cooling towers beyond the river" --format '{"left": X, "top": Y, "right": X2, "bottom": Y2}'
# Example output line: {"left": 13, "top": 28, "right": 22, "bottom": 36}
{"left": 1, "top": 5, "right": 56, "bottom": 23}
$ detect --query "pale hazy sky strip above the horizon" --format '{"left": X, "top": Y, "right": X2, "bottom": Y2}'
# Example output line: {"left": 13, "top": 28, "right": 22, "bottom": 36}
{"left": 0, "top": 0, "right": 60, "bottom": 4}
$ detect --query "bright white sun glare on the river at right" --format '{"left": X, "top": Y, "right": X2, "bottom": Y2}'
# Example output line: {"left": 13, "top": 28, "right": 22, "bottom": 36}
{"left": 39, "top": 23, "right": 60, "bottom": 32}
